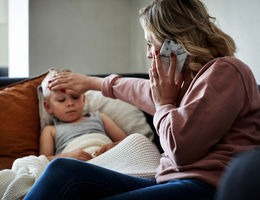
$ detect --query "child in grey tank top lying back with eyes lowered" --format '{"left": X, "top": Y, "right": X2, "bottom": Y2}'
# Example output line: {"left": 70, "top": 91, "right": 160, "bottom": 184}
{"left": 40, "top": 69, "right": 126, "bottom": 161}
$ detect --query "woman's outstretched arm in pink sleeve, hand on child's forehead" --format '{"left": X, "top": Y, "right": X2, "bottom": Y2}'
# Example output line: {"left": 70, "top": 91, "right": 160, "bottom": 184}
{"left": 49, "top": 72, "right": 155, "bottom": 115}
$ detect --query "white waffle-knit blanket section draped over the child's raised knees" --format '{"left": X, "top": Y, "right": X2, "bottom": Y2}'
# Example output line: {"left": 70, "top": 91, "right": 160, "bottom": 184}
{"left": 88, "top": 133, "right": 161, "bottom": 178}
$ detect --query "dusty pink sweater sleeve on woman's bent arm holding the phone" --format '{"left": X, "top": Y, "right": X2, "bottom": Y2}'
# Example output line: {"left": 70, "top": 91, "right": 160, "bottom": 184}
{"left": 154, "top": 61, "right": 245, "bottom": 166}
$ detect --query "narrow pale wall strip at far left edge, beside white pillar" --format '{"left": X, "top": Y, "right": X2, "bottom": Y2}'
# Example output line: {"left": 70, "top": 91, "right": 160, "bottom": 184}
{"left": 0, "top": 0, "right": 8, "bottom": 67}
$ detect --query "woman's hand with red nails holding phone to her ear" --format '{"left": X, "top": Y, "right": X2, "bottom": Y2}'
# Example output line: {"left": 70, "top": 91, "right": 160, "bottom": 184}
{"left": 149, "top": 50, "right": 183, "bottom": 109}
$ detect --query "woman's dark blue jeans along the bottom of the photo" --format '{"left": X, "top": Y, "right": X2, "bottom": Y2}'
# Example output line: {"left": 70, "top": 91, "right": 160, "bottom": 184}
{"left": 24, "top": 158, "right": 215, "bottom": 200}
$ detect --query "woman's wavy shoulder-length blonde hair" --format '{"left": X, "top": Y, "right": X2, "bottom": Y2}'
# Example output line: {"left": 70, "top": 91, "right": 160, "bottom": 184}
{"left": 140, "top": 0, "right": 236, "bottom": 74}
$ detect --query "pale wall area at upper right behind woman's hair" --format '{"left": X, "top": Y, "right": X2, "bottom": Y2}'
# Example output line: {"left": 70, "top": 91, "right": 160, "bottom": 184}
{"left": 203, "top": 0, "right": 260, "bottom": 84}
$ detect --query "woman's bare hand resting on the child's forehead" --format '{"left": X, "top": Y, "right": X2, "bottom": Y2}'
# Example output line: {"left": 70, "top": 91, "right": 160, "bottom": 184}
{"left": 49, "top": 72, "right": 102, "bottom": 94}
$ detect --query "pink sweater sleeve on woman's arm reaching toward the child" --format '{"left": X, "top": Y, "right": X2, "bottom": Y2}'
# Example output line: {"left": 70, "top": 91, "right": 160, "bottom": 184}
{"left": 102, "top": 74, "right": 155, "bottom": 115}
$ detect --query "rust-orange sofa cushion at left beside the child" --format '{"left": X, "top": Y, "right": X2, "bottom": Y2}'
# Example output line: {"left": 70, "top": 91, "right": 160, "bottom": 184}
{"left": 0, "top": 74, "right": 46, "bottom": 170}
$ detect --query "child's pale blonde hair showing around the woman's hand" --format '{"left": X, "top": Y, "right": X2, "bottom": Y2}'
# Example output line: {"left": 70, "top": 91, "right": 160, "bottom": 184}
{"left": 41, "top": 68, "right": 70, "bottom": 98}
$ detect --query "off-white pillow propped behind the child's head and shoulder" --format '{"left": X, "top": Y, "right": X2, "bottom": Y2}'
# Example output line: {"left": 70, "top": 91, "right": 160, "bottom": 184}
{"left": 37, "top": 86, "right": 153, "bottom": 141}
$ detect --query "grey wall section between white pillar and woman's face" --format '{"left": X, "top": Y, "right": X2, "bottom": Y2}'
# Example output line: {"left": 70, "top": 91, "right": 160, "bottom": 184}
{"left": 29, "top": 0, "right": 151, "bottom": 76}
